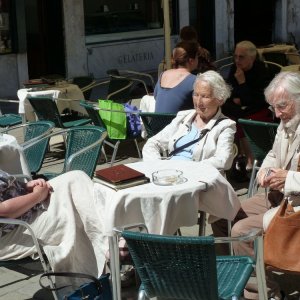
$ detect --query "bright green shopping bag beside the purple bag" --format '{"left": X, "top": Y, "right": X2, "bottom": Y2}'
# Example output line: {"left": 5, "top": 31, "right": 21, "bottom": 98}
{"left": 98, "top": 99, "right": 127, "bottom": 140}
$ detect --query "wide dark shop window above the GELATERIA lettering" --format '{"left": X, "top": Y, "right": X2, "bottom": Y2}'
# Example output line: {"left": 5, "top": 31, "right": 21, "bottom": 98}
{"left": 84, "top": 0, "right": 176, "bottom": 44}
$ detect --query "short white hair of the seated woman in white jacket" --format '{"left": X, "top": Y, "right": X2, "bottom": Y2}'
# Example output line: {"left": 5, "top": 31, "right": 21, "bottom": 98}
{"left": 193, "top": 70, "right": 231, "bottom": 102}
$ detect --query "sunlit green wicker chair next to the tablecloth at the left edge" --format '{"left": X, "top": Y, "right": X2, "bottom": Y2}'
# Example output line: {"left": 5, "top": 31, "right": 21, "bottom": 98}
{"left": 2, "top": 121, "right": 55, "bottom": 176}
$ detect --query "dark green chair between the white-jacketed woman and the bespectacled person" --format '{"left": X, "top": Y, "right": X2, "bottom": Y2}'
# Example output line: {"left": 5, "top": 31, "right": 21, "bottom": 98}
{"left": 238, "top": 119, "right": 279, "bottom": 197}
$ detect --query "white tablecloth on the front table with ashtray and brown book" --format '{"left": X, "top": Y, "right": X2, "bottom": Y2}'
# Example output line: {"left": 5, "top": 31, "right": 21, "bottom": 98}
{"left": 95, "top": 160, "right": 240, "bottom": 236}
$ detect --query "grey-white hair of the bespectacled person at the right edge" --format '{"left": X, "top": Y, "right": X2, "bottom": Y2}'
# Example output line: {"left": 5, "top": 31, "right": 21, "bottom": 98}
{"left": 265, "top": 72, "right": 300, "bottom": 104}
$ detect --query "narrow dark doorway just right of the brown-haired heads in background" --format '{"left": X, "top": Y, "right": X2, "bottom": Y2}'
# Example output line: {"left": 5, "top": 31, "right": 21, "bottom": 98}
{"left": 191, "top": 0, "right": 216, "bottom": 56}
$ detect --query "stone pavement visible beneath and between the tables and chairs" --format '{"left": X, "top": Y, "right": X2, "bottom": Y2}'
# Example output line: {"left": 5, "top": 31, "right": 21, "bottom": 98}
{"left": 0, "top": 131, "right": 300, "bottom": 300}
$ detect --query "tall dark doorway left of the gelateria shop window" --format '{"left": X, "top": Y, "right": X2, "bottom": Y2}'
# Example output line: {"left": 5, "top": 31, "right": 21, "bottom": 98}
{"left": 25, "top": 0, "right": 66, "bottom": 78}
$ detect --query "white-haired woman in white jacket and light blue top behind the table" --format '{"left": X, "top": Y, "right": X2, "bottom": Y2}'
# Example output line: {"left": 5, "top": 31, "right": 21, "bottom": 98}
{"left": 143, "top": 71, "right": 236, "bottom": 172}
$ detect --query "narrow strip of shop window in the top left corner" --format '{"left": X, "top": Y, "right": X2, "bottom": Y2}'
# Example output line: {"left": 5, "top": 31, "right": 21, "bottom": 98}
{"left": 0, "top": 0, "right": 12, "bottom": 54}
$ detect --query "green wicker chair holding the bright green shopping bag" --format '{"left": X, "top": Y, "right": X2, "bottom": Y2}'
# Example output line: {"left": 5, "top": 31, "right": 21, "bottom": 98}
{"left": 80, "top": 101, "right": 142, "bottom": 166}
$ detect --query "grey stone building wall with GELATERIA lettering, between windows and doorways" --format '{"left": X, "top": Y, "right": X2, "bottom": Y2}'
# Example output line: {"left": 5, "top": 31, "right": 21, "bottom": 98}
{"left": 0, "top": 0, "right": 300, "bottom": 99}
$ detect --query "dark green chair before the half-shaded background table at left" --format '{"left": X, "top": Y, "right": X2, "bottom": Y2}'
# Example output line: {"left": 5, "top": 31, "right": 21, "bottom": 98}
{"left": 28, "top": 96, "right": 91, "bottom": 128}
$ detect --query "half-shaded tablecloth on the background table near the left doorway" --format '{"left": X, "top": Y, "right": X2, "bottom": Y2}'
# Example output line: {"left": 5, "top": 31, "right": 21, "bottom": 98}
{"left": 18, "top": 84, "right": 87, "bottom": 121}
